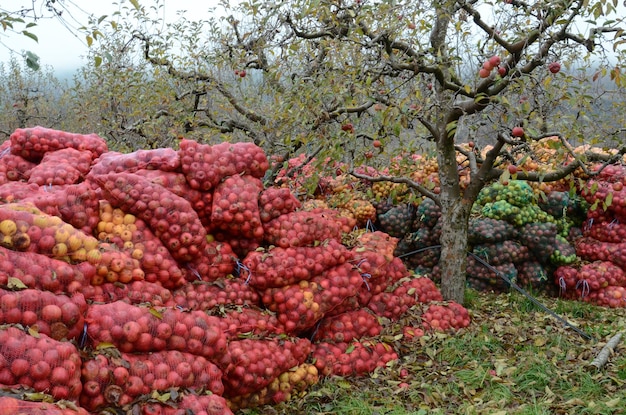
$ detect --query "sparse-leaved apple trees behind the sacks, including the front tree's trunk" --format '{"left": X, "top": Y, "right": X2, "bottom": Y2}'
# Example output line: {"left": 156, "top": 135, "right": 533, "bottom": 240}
{"left": 0, "top": 0, "right": 626, "bottom": 302}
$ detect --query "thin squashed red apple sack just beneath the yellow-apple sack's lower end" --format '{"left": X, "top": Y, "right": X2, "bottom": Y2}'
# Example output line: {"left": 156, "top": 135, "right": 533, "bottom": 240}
{"left": 80, "top": 281, "right": 176, "bottom": 307}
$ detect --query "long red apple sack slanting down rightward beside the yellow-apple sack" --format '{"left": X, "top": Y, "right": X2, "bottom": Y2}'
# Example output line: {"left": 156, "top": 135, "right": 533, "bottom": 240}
{"left": 91, "top": 173, "right": 206, "bottom": 261}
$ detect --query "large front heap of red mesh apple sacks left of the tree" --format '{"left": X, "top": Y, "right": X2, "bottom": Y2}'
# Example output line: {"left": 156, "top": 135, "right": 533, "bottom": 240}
{"left": 0, "top": 127, "right": 469, "bottom": 415}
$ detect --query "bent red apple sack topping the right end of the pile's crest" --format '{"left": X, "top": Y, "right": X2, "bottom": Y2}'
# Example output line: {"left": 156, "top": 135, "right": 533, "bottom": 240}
{"left": 179, "top": 139, "right": 269, "bottom": 191}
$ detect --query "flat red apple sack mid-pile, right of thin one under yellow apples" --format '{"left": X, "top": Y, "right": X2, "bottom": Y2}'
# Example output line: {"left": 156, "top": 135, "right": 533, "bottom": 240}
{"left": 173, "top": 278, "right": 260, "bottom": 311}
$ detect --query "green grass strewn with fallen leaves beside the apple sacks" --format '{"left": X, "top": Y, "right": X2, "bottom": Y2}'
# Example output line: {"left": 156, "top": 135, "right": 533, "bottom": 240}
{"left": 241, "top": 290, "right": 626, "bottom": 415}
